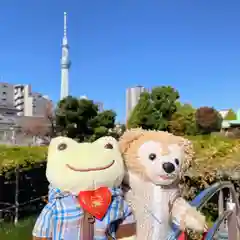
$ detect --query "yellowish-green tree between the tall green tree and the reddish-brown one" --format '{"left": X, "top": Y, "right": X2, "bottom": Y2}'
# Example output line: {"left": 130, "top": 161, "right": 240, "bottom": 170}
{"left": 169, "top": 104, "right": 197, "bottom": 136}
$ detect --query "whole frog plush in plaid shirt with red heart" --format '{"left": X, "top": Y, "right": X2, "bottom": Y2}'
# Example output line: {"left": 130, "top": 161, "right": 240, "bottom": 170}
{"left": 33, "top": 137, "right": 135, "bottom": 240}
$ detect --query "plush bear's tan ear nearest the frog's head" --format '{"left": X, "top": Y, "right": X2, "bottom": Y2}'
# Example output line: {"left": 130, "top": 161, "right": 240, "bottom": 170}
{"left": 119, "top": 128, "right": 144, "bottom": 154}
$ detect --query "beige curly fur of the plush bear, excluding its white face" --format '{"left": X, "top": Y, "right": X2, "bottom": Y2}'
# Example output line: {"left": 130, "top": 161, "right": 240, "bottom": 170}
{"left": 119, "top": 128, "right": 205, "bottom": 240}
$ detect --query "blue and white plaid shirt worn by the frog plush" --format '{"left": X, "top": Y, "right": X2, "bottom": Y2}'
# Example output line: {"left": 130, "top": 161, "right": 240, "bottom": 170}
{"left": 33, "top": 188, "right": 134, "bottom": 240}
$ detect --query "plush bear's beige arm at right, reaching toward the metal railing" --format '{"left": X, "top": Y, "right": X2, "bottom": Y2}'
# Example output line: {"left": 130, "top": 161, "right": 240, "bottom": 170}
{"left": 171, "top": 197, "right": 206, "bottom": 232}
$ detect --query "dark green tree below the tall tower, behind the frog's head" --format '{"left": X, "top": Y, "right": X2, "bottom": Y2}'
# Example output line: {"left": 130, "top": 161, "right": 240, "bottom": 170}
{"left": 56, "top": 96, "right": 116, "bottom": 142}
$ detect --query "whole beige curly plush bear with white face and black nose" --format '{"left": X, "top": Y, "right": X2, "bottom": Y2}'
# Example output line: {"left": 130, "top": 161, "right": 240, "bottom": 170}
{"left": 119, "top": 129, "right": 205, "bottom": 240}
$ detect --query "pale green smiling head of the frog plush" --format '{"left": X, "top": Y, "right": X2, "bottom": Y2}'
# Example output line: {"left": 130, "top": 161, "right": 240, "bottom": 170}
{"left": 46, "top": 137, "right": 124, "bottom": 194}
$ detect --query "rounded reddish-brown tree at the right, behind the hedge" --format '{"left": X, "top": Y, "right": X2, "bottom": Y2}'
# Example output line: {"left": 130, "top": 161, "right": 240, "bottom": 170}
{"left": 196, "top": 107, "right": 222, "bottom": 134}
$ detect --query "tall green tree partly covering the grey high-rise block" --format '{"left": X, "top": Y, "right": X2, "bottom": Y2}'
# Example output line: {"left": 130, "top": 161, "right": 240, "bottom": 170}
{"left": 127, "top": 86, "right": 179, "bottom": 130}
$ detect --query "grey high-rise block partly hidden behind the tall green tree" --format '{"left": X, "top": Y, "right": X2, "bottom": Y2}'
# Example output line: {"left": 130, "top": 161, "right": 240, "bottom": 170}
{"left": 126, "top": 86, "right": 146, "bottom": 120}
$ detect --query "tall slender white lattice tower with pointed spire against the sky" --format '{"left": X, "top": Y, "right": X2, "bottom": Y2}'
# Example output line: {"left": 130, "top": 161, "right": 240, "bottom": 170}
{"left": 60, "top": 12, "right": 71, "bottom": 99}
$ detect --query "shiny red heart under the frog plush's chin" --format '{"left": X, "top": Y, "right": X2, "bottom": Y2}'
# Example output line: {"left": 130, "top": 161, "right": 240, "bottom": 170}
{"left": 78, "top": 187, "right": 112, "bottom": 220}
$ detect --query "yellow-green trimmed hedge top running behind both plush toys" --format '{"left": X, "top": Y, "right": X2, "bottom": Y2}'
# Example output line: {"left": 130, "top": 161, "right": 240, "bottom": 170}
{"left": 0, "top": 136, "right": 240, "bottom": 176}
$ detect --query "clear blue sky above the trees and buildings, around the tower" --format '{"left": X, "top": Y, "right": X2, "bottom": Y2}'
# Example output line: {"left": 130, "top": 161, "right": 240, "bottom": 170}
{"left": 0, "top": 0, "right": 240, "bottom": 123}
